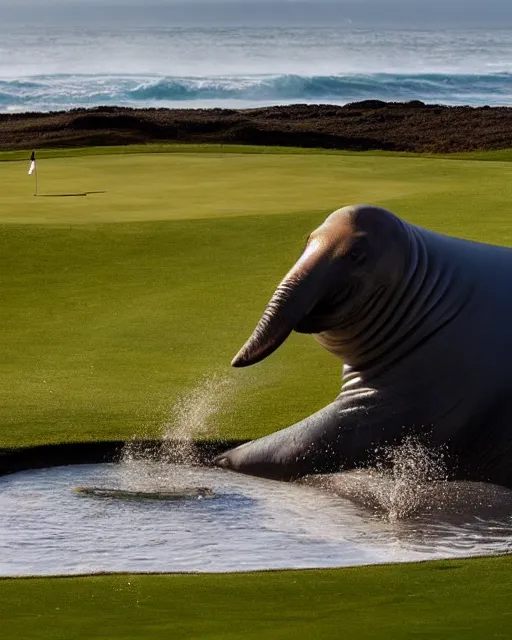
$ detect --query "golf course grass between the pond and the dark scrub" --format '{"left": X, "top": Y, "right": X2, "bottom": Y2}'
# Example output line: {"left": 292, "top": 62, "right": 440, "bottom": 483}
{"left": 0, "top": 148, "right": 512, "bottom": 446}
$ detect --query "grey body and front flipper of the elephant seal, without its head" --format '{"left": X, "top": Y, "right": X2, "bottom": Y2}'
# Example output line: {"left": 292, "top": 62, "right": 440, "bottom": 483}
{"left": 217, "top": 207, "right": 512, "bottom": 487}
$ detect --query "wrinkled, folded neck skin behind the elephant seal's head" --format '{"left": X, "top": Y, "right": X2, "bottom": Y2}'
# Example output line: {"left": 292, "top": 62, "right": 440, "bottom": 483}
{"left": 314, "top": 221, "right": 471, "bottom": 384}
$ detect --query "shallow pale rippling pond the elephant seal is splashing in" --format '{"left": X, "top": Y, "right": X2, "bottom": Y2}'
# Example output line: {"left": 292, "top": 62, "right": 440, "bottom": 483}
{"left": 0, "top": 461, "right": 512, "bottom": 576}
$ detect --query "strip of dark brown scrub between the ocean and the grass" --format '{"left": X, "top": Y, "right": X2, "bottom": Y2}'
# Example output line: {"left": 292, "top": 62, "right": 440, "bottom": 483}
{"left": 0, "top": 100, "right": 512, "bottom": 153}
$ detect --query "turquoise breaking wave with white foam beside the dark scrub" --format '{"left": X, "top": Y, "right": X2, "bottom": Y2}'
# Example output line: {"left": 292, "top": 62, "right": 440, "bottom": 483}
{"left": 0, "top": 72, "right": 512, "bottom": 112}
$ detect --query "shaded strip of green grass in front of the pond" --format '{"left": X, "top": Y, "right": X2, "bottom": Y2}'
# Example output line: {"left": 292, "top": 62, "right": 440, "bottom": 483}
{"left": 4, "top": 556, "right": 512, "bottom": 640}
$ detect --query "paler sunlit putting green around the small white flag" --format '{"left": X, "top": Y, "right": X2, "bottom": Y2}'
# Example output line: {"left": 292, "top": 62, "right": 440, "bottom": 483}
{"left": 4, "top": 151, "right": 502, "bottom": 225}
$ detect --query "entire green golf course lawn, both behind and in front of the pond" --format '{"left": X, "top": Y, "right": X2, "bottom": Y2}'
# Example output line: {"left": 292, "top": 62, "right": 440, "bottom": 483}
{"left": 0, "top": 147, "right": 512, "bottom": 640}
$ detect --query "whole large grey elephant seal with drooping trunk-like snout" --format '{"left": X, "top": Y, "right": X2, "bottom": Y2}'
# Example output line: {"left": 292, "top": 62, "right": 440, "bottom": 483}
{"left": 215, "top": 205, "right": 512, "bottom": 487}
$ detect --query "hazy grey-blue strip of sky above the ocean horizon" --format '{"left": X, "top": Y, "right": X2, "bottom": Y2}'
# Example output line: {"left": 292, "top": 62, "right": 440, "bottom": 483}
{"left": 4, "top": 0, "right": 512, "bottom": 28}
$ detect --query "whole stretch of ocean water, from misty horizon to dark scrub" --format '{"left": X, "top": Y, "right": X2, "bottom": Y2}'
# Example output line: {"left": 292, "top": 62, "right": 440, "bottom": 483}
{"left": 0, "top": 0, "right": 512, "bottom": 113}
